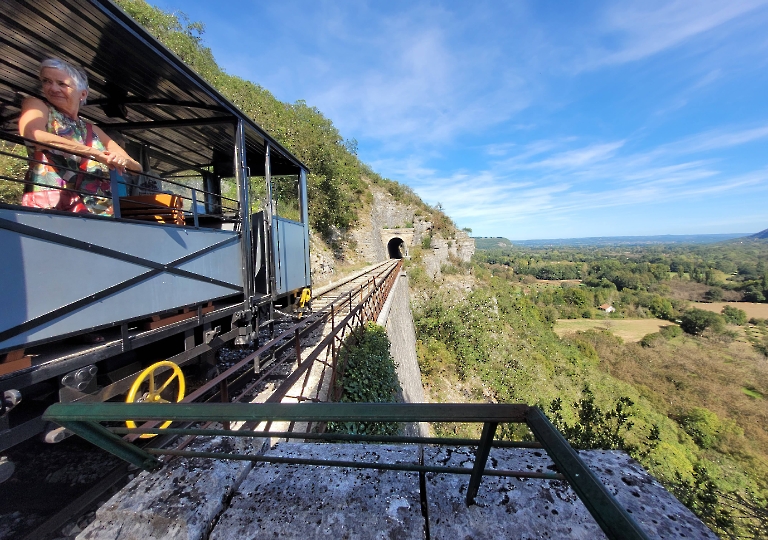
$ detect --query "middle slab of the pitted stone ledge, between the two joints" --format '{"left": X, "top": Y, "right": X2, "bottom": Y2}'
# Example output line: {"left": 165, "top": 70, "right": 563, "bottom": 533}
{"left": 210, "top": 443, "right": 425, "bottom": 540}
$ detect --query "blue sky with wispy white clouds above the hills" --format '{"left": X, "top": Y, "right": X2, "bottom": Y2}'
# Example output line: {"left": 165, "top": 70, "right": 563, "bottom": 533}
{"left": 146, "top": 0, "right": 768, "bottom": 240}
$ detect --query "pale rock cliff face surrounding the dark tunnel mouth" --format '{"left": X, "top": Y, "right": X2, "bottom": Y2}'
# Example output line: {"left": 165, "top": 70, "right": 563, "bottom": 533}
{"left": 311, "top": 186, "right": 475, "bottom": 283}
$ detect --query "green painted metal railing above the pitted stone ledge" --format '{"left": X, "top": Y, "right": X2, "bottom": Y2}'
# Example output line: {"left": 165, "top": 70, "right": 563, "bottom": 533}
{"left": 43, "top": 403, "right": 648, "bottom": 540}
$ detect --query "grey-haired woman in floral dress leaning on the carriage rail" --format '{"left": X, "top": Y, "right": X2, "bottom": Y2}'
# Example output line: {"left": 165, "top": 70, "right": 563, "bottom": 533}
{"left": 19, "top": 58, "right": 141, "bottom": 215}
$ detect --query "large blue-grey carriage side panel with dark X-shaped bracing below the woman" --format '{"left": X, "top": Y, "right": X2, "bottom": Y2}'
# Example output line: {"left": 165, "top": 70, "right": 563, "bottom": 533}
{"left": 0, "top": 208, "right": 243, "bottom": 351}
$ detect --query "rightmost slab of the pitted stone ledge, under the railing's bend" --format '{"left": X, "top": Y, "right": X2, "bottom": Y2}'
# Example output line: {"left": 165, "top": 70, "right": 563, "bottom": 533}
{"left": 424, "top": 447, "right": 717, "bottom": 540}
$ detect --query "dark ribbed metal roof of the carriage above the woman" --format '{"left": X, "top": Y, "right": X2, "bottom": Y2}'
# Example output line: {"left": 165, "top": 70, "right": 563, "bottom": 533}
{"left": 0, "top": 0, "right": 307, "bottom": 175}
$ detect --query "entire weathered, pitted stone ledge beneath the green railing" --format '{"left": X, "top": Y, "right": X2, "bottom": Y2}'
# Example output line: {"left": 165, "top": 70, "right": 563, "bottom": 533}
{"left": 78, "top": 439, "right": 717, "bottom": 540}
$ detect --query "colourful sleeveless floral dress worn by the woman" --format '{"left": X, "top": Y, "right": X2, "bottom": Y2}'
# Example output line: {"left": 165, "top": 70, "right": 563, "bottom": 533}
{"left": 27, "top": 105, "right": 112, "bottom": 216}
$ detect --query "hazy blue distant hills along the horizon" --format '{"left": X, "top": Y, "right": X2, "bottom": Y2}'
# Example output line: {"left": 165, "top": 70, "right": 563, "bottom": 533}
{"left": 475, "top": 229, "right": 752, "bottom": 250}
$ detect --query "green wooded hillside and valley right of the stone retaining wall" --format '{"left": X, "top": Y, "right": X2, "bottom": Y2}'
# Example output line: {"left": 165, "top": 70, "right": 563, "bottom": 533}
{"left": 424, "top": 246, "right": 768, "bottom": 538}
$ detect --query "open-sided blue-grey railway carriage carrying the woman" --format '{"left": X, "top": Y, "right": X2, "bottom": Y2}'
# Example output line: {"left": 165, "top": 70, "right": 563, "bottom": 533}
{"left": 0, "top": 0, "right": 310, "bottom": 451}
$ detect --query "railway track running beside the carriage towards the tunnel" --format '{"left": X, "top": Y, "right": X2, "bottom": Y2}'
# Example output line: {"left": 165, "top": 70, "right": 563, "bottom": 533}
{"left": 7, "top": 260, "right": 400, "bottom": 540}
